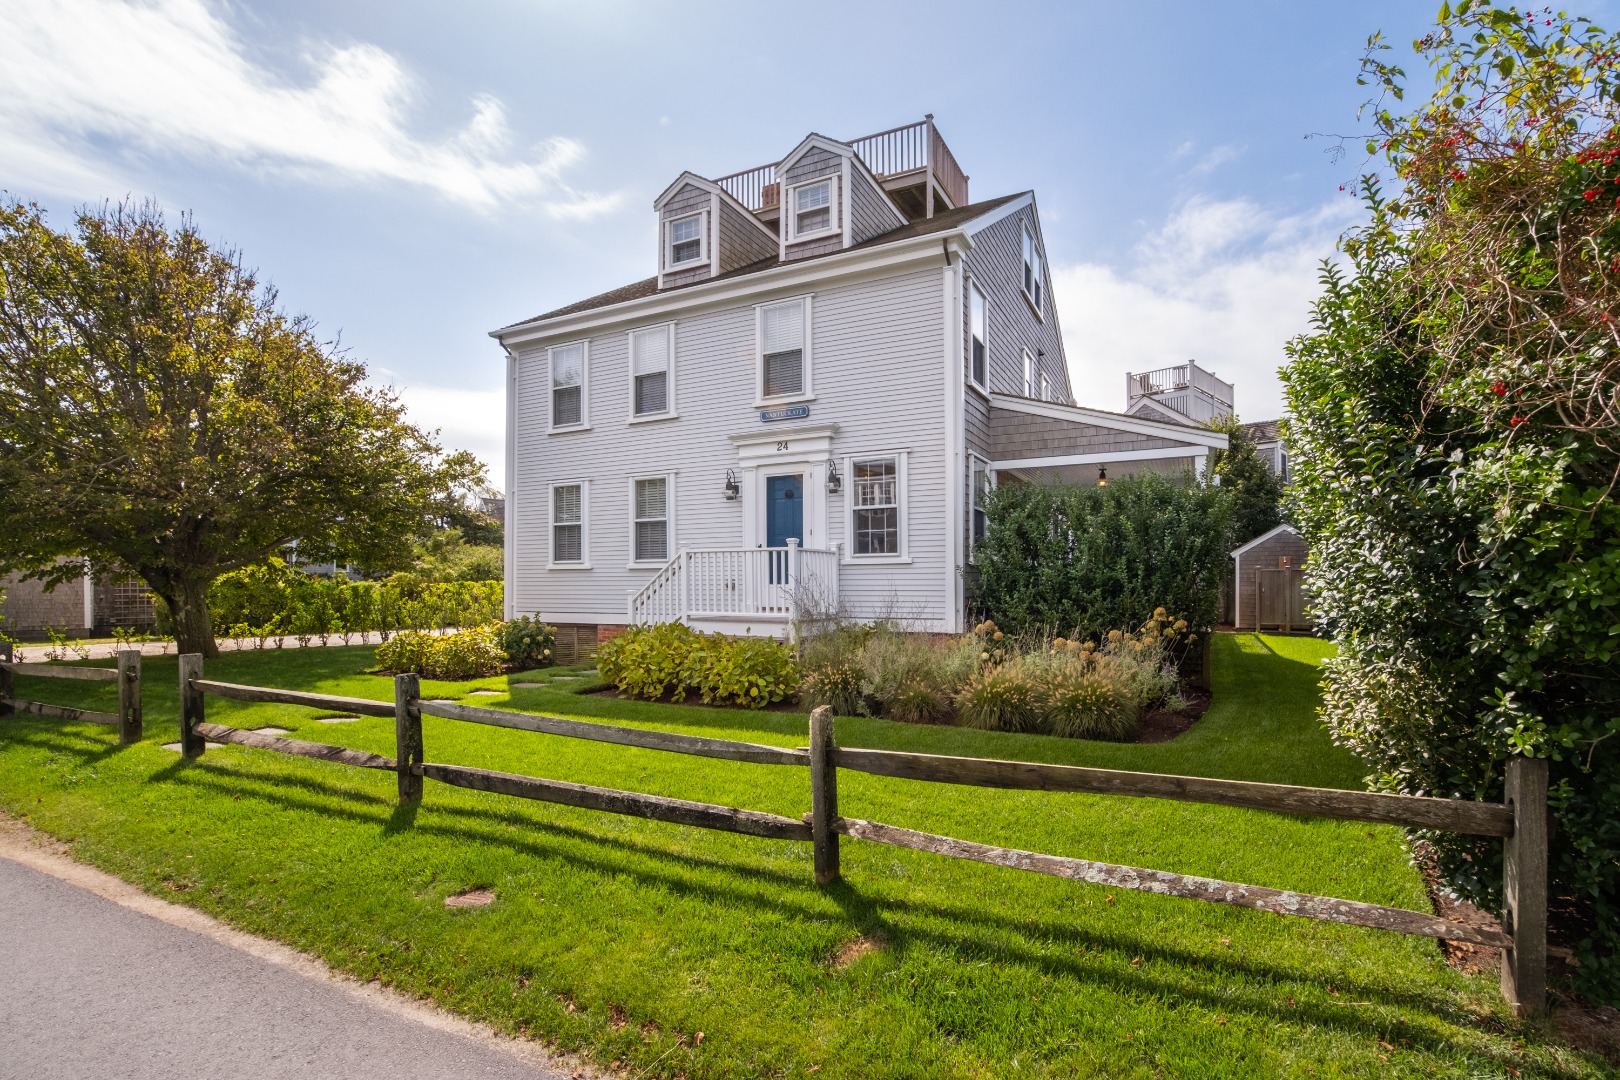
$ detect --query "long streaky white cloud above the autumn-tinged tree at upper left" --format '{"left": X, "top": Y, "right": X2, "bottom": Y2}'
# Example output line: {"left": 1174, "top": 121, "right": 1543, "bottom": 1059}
{"left": 0, "top": 0, "right": 617, "bottom": 217}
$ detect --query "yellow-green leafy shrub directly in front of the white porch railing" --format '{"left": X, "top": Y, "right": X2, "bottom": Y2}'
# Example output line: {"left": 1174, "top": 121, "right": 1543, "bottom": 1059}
{"left": 596, "top": 622, "right": 799, "bottom": 709}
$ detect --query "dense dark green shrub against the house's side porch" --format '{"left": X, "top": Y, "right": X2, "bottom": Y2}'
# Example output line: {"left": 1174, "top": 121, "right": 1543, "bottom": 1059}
{"left": 974, "top": 473, "right": 1231, "bottom": 633}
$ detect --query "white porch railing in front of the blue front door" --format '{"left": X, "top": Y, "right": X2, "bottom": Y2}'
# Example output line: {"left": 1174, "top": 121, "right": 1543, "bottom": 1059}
{"left": 629, "top": 541, "right": 838, "bottom": 625}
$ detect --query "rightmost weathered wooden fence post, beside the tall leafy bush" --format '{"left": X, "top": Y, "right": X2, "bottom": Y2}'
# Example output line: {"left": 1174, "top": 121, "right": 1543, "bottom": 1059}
{"left": 1502, "top": 758, "right": 1547, "bottom": 1017}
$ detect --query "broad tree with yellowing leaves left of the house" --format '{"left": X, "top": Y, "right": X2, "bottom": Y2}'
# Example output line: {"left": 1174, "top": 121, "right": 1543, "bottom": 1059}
{"left": 0, "top": 201, "right": 481, "bottom": 656}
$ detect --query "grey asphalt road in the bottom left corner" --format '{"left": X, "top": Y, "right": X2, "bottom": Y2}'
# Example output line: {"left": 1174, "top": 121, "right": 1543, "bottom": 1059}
{"left": 0, "top": 858, "right": 564, "bottom": 1080}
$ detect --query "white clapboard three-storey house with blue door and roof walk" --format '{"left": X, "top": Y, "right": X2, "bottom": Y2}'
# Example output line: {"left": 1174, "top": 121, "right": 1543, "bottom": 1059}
{"left": 492, "top": 117, "right": 1226, "bottom": 636}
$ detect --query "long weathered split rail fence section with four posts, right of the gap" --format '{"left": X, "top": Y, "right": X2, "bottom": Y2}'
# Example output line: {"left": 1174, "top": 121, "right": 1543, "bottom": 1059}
{"left": 170, "top": 654, "right": 1547, "bottom": 1015}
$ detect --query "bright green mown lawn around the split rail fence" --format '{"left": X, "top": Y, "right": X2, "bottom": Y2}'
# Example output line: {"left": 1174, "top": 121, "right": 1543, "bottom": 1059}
{"left": 0, "top": 635, "right": 1607, "bottom": 1080}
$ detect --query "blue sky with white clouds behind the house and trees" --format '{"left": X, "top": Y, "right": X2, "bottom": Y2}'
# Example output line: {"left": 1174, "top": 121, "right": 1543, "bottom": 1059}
{"left": 9, "top": 0, "right": 1614, "bottom": 478}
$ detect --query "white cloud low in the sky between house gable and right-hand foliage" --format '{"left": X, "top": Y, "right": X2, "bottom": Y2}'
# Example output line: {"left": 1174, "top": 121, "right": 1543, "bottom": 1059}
{"left": 1053, "top": 198, "right": 1359, "bottom": 419}
